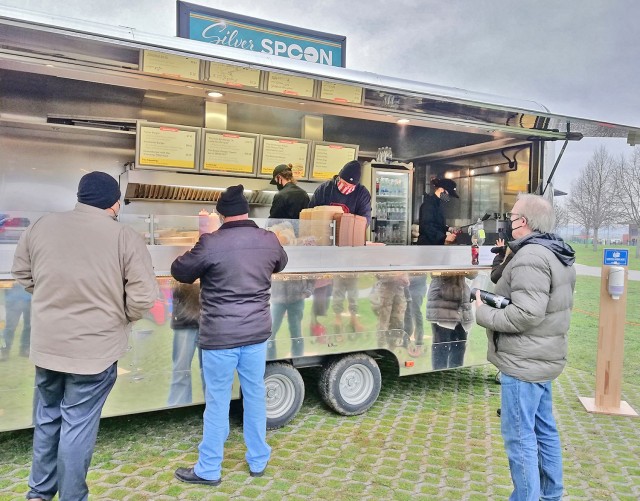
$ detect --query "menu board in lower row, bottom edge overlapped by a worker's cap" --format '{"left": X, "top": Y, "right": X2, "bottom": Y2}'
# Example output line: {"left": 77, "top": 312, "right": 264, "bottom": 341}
{"left": 259, "top": 136, "right": 311, "bottom": 179}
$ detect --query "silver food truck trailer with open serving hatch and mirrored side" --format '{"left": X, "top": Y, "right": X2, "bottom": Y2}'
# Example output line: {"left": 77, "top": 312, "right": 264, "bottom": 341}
{"left": 0, "top": 7, "right": 640, "bottom": 431}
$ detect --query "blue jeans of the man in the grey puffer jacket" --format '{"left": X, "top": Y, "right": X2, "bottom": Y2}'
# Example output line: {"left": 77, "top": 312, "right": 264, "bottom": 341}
{"left": 500, "top": 373, "right": 563, "bottom": 501}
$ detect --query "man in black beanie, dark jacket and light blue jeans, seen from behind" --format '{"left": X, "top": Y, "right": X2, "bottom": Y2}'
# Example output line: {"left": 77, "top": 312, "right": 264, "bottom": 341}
{"left": 171, "top": 185, "right": 287, "bottom": 485}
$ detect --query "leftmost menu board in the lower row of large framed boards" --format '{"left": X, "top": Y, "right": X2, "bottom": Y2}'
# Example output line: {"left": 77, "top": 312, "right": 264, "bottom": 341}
{"left": 136, "top": 122, "right": 200, "bottom": 171}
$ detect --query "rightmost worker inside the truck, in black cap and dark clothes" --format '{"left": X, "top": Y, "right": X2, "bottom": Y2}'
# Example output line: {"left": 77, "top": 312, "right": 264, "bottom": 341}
{"left": 418, "top": 178, "right": 460, "bottom": 245}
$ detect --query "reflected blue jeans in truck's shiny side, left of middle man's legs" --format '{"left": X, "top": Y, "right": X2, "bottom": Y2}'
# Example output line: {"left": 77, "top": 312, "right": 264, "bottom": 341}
{"left": 167, "top": 328, "right": 204, "bottom": 405}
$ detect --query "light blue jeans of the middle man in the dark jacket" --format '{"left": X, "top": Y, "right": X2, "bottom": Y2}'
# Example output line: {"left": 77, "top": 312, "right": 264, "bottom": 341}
{"left": 194, "top": 341, "right": 271, "bottom": 480}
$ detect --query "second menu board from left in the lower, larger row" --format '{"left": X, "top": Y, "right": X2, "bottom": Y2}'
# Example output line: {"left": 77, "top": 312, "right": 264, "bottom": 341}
{"left": 201, "top": 129, "right": 258, "bottom": 175}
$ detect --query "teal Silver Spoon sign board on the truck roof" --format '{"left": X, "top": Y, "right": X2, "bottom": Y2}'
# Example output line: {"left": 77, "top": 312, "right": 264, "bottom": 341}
{"left": 178, "top": 1, "right": 347, "bottom": 67}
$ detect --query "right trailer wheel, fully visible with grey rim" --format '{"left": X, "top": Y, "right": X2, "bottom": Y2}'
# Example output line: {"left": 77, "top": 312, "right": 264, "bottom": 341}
{"left": 319, "top": 353, "right": 382, "bottom": 416}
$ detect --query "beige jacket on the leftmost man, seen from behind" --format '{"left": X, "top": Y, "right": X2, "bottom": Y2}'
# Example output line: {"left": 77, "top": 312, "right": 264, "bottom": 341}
{"left": 11, "top": 203, "right": 158, "bottom": 374}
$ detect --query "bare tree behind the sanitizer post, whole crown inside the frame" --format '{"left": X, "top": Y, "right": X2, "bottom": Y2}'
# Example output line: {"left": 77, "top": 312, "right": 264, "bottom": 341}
{"left": 569, "top": 146, "right": 619, "bottom": 251}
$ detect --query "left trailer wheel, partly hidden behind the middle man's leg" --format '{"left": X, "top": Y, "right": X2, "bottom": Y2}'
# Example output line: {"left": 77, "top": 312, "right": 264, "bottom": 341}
{"left": 264, "top": 362, "right": 304, "bottom": 430}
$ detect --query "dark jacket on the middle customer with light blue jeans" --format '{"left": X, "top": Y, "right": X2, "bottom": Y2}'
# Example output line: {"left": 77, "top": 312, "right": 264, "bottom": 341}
{"left": 171, "top": 220, "right": 287, "bottom": 350}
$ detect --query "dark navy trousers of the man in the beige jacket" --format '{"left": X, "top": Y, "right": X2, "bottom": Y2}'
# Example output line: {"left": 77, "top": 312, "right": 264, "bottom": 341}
{"left": 27, "top": 364, "right": 117, "bottom": 501}
